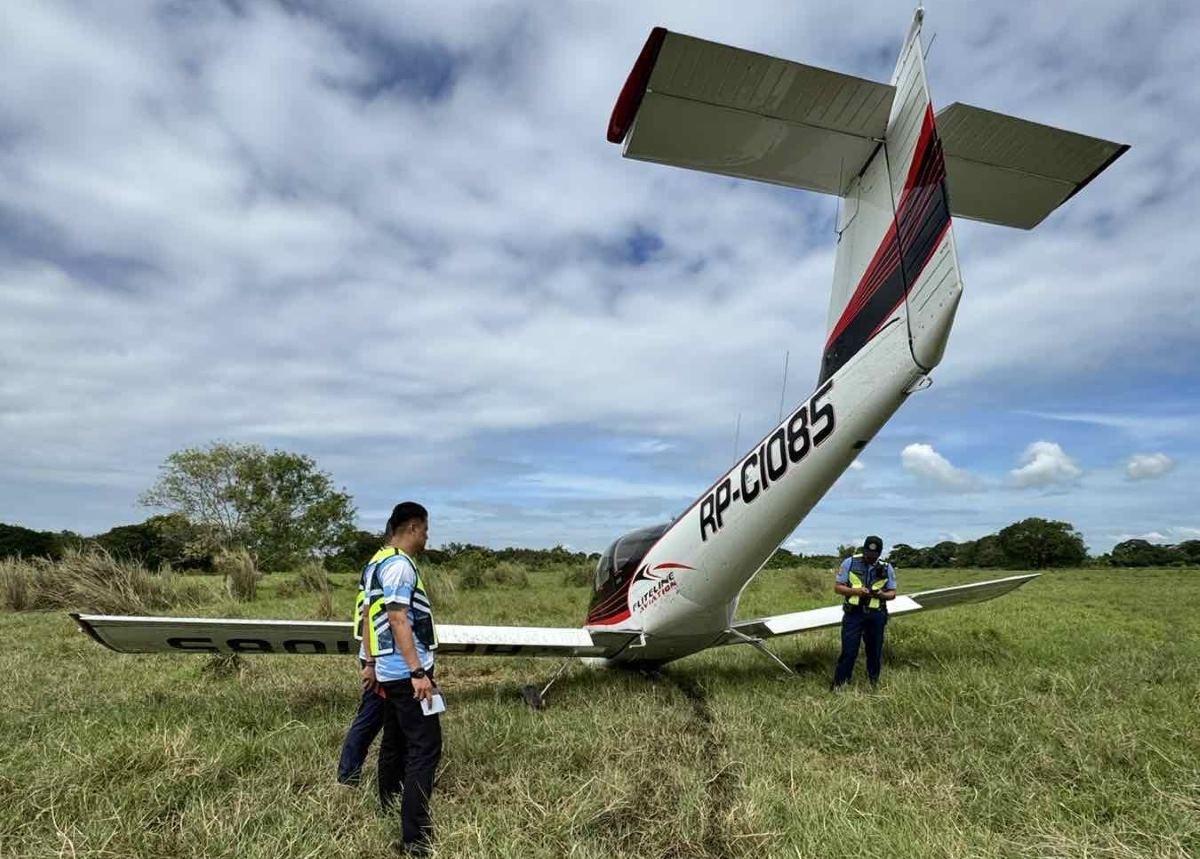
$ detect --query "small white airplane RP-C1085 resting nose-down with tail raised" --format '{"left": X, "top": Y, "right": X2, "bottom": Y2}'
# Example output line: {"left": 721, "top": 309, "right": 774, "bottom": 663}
{"left": 73, "top": 8, "right": 1128, "bottom": 668}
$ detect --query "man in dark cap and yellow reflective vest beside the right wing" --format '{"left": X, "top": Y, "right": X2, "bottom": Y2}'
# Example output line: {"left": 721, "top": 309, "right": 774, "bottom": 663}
{"left": 832, "top": 536, "right": 896, "bottom": 689}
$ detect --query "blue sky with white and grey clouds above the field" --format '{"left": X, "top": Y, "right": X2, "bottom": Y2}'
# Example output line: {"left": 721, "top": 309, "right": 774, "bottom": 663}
{"left": 0, "top": 0, "right": 1200, "bottom": 552}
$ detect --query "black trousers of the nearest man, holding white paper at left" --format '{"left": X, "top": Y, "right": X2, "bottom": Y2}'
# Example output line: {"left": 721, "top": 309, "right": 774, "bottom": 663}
{"left": 379, "top": 680, "right": 442, "bottom": 847}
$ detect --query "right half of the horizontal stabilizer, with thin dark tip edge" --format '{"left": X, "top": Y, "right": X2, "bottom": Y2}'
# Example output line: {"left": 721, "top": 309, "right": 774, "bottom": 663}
{"left": 937, "top": 103, "right": 1129, "bottom": 229}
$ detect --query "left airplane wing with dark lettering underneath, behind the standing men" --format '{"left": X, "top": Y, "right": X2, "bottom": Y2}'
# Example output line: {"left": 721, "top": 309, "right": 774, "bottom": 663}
{"left": 71, "top": 613, "right": 637, "bottom": 657}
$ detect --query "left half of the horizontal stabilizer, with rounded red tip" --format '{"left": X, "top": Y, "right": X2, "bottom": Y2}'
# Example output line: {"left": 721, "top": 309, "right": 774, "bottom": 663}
{"left": 608, "top": 28, "right": 895, "bottom": 196}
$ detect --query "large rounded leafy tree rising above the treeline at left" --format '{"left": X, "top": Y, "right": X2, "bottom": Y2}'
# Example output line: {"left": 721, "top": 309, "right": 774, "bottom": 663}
{"left": 142, "top": 441, "right": 354, "bottom": 570}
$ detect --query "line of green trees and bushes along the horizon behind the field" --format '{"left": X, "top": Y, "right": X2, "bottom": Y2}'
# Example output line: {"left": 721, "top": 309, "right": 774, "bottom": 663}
{"left": 0, "top": 441, "right": 1200, "bottom": 576}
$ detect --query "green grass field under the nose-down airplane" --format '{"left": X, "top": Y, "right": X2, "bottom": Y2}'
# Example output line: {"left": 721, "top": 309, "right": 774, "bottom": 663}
{"left": 0, "top": 570, "right": 1200, "bottom": 859}
